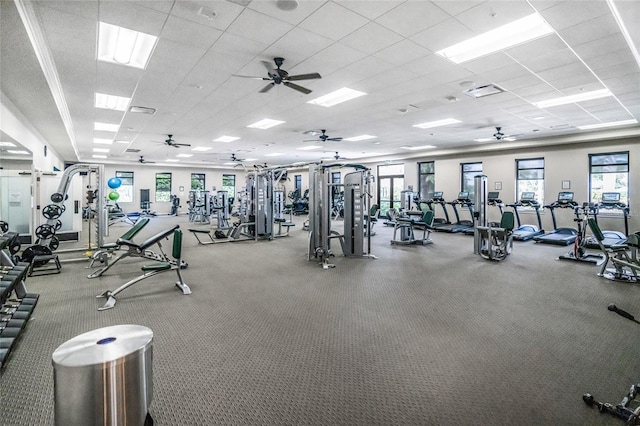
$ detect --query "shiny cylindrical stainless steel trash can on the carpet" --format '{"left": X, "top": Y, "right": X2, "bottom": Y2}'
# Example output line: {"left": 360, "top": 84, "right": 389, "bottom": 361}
{"left": 52, "top": 324, "right": 153, "bottom": 426}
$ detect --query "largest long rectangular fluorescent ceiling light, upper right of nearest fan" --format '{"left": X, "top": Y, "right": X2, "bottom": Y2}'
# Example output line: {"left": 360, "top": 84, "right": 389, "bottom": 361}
{"left": 436, "top": 13, "right": 554, "bottom": 64}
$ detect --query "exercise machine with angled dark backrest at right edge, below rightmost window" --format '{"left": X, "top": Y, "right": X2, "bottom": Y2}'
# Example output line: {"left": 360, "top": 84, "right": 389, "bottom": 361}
{"left": 587, "top": 217, "right": 640, "bottom": 282}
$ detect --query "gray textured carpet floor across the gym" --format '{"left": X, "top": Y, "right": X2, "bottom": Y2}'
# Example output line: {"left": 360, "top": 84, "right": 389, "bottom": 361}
{"left": 0, "top": 216, "right": 640, "bottom": 425}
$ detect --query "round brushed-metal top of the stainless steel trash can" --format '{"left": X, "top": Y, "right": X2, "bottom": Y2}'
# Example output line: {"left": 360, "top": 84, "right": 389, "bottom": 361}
{"left": 52, "top": 324, "right": 153, "bottom": 367}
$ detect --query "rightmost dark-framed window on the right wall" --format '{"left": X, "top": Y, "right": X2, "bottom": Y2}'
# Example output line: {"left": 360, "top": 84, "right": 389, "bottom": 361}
{"left": 589, "top": 151, "right": 629, "bottom": 206}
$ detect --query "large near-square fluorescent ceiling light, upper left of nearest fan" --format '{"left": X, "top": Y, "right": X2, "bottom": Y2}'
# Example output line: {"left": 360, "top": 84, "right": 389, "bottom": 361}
{"left": 98, "top": 22, "right": 158, "bottom": 69}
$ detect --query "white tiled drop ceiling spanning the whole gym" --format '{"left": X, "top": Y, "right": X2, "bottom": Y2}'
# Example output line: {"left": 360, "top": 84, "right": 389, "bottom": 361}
{"left": 0, "top": 0, "right": 640, "bottom": 167}
